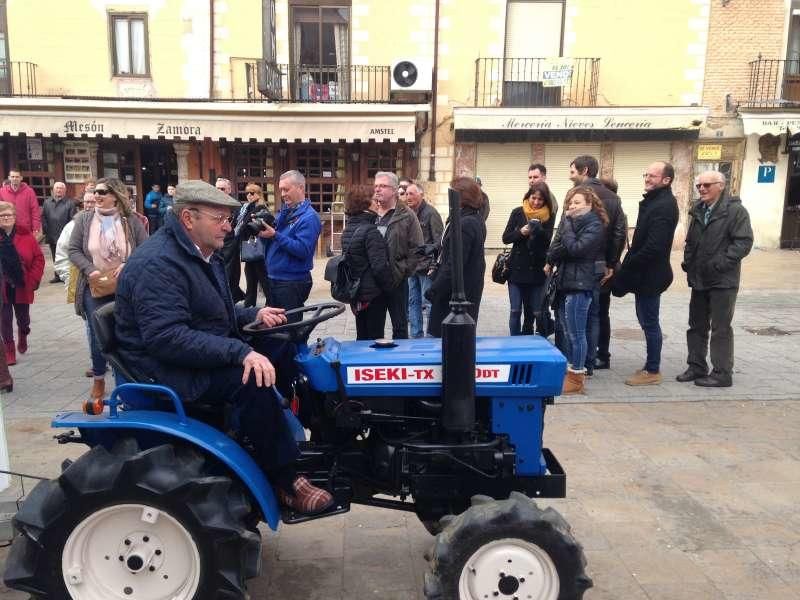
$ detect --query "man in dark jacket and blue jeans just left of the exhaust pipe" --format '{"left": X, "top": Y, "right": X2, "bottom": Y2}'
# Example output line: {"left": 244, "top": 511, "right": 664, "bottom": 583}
{"left": 406, "top": 183, "right": 444, "bottom": 338}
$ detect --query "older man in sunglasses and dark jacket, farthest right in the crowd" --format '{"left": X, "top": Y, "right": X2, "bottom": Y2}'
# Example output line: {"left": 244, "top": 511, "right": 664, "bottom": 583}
{"left": 676, "top": 171, "right": 753, "bottom": 387}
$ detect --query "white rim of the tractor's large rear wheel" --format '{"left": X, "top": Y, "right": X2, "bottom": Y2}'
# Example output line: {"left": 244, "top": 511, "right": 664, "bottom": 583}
{"left": 61, "top": 504, "right": 200, "bottom": 600}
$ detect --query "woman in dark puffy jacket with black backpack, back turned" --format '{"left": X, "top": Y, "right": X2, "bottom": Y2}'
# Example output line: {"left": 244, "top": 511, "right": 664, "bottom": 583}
{"left": 342, "top": 185, "right": 392, "bottom": 340}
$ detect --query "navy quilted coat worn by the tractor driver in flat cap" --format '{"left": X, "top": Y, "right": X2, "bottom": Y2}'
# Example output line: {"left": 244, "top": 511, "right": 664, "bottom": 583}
{"left": 114, "top": 214, "right": 259, "bottom": 402}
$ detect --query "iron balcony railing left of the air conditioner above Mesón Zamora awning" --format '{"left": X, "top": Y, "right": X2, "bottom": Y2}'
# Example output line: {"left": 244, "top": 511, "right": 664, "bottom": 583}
{"left": 245, "top": 60, "right": 391, "bottom": 103}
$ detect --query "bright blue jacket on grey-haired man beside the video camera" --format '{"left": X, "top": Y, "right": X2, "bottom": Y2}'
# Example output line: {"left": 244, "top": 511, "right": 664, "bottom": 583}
{"left": 267, "top": 200, "right": 322, "bottom": 281}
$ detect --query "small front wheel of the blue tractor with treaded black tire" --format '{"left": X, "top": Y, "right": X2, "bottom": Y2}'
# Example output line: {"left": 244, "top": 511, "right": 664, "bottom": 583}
{"left": 425, "top": 492, "right": 592, "bottom": 600}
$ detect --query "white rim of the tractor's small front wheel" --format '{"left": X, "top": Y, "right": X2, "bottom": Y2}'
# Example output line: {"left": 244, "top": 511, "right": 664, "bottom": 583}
{"left": 458, "top": 538, "right": 559, "bottom": 600}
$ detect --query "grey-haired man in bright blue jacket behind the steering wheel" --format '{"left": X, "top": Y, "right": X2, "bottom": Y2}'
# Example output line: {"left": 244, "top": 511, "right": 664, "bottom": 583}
{"left": 259, "top": 171, "right": 322, "bottom": 318}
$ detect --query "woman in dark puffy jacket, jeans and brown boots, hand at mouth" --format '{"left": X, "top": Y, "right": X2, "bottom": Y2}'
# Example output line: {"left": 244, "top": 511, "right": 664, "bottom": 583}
{"left": 545, "top": 187, "right": 608, "bottom": 394}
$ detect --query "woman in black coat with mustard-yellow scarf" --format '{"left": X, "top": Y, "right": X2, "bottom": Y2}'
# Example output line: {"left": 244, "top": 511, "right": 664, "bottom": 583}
{"left": 503, "top": 183, "right": 555, "bottom": 335}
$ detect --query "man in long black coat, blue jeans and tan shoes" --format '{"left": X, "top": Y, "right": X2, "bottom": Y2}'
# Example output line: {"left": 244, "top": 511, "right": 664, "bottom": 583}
{"left": 612, "top": 161, "right": 678, "bottom": 385}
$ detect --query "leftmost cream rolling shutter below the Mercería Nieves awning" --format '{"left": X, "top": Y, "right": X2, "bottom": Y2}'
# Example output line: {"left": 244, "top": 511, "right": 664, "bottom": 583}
{"left": 475, "top": 144, "right": 531, "bottom": 248}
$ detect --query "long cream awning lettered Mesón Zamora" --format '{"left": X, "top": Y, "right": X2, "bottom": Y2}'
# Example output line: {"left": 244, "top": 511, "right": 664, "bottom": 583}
{"left": 0, "top": 98, "right": 428, "bottom": 142}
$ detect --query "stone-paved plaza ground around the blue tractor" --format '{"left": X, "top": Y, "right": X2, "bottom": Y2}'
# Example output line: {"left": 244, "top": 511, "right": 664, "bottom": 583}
{"left": 0, "top": 251, "right": 800, "bottom": 600}
